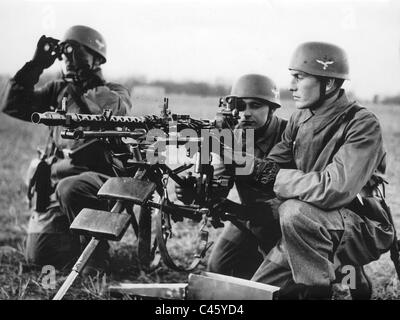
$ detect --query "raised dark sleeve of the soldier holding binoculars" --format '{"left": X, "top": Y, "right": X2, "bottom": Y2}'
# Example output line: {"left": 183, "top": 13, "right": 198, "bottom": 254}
{"left": 3, "top": 62, "right": 57, "bottom": 121}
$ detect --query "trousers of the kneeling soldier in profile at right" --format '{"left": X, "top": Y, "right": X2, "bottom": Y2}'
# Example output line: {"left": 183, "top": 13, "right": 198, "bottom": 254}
{"left": 251, "top": 199, "right": 393, "bottom": 290}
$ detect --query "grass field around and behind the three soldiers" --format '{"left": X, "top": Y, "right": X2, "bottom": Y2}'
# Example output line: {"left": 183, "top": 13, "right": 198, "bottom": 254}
{"left": 0, "top": 90, "right": 400, "bottom": 299}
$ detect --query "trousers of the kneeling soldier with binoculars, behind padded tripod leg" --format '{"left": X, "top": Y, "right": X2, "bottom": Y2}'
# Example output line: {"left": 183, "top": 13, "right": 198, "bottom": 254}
{"left": 25, "top": 171, "right": 108, "bottom": 269}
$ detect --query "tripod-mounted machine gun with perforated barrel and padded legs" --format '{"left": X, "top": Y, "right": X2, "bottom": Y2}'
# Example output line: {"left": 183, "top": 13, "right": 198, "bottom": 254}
{"left": 32, "top": 99, "right": 262, "bottom": 299}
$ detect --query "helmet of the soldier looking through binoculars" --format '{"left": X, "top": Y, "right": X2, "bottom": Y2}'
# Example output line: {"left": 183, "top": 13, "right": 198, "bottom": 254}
{"left": 62, "top": 26, "right": 107, "bottom": 63}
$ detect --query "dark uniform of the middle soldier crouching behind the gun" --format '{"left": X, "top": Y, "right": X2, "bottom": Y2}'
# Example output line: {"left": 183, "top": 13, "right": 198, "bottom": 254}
{"left": 208, "top": 116, "right": 287, "bottom": 279}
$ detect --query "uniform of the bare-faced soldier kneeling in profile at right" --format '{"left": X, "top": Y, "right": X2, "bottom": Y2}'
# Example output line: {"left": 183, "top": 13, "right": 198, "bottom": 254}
{"left": 252, "top": 89, "right": 394, "bottom": 288}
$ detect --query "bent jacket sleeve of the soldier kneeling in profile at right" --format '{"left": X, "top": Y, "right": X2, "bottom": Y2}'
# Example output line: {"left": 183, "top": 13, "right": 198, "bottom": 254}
{"left": 274, "top": 111, "right": 384, "bottom": 209}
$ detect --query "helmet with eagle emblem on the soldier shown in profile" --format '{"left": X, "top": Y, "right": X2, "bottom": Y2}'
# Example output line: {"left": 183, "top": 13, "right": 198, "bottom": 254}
{"left": 289, "top": 42, "right": 349, "bottom": 80}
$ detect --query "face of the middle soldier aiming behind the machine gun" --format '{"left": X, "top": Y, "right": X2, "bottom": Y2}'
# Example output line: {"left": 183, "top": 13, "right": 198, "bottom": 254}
{"left": 239, "top": 98, "right": 269, "bottom": 129}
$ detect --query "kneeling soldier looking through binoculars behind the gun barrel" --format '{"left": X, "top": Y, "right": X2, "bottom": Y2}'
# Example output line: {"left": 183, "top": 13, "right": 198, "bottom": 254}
{"left": 3, "top": 25, "right": 131, "bottom": 276}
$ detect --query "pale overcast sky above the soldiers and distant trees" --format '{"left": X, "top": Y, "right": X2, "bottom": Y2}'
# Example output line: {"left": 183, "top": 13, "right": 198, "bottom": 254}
{"left": 0, "top": 0, "right": 400, "bottom": 97}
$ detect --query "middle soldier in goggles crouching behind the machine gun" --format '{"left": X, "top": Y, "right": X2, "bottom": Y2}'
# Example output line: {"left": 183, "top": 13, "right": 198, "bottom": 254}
{"left": 176, "top": 74, "right": 287, "bottom": 279}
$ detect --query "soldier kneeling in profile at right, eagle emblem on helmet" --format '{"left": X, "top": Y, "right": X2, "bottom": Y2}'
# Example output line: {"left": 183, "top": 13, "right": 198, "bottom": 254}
{"left": 252, "top": 42, "right": 394, "bottom": 299}
